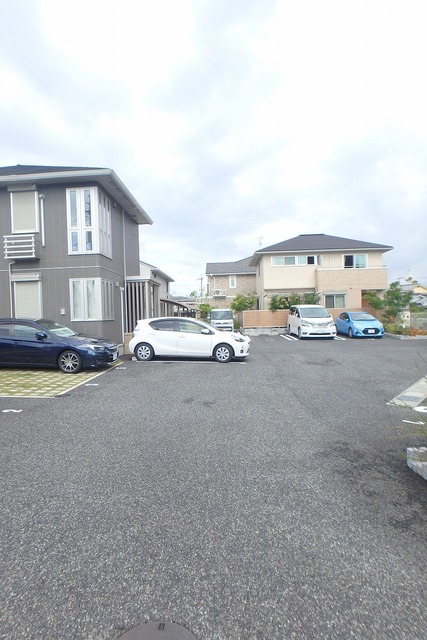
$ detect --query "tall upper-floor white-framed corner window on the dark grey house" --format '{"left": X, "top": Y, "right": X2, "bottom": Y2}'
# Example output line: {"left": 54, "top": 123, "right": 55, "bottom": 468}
{"left": 67, "top": 187, "right": 112, "bottom": 258}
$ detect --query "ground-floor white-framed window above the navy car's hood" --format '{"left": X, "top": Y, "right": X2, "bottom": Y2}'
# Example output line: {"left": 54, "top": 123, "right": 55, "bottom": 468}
{"left": 70, "top": 278, "right": 114, "bottom": 320}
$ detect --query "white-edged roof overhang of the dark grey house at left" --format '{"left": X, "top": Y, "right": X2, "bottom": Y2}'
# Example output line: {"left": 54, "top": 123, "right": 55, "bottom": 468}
{"left": 0, "top": 169, "right": 153, "bottom": 224}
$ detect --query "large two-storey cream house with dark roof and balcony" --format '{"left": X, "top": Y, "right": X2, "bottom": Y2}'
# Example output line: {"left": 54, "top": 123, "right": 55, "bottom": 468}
{"left": 250, "top": 233, "right": 393, "bottom": 310}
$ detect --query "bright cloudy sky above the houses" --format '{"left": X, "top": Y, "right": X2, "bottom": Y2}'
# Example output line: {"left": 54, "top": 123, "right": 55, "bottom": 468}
{"left": 0, "top": 0, "right": 427, "bottom": 295}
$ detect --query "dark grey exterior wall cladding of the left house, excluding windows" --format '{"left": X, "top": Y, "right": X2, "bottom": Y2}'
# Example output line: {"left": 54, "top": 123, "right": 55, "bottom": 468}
{"left": 0, "top": 181, "right": 144, "bottom": 343}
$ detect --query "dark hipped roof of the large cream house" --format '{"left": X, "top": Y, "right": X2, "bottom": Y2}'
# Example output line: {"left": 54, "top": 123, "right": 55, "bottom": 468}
{"left": 250, "top": 233, "right": 393, "bottom": 267}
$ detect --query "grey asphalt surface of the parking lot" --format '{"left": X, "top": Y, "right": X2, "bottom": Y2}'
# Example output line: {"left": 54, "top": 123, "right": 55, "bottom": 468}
{"left": 0, "top": 336, "right": 427, "bottom": 640}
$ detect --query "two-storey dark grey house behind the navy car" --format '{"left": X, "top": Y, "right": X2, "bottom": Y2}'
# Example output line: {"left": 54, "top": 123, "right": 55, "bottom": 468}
{"left": 0, "top": 165, "right": 152, "bottom": 343}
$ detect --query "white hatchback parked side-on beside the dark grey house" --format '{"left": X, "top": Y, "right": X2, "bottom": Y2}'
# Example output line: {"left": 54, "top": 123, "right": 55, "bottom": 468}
{"left": 129, "top": 317, "right": 251, "bottom": 362}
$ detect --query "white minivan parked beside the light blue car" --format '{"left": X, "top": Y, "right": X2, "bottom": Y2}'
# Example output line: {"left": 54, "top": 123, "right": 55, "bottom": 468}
{"left": 288, "top": 304, "right": 337, "bottom": 339}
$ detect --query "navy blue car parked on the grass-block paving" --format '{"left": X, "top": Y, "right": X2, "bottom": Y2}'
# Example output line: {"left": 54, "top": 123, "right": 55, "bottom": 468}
{"left": 0, "top": 318, "right": 118, "bottom": 373}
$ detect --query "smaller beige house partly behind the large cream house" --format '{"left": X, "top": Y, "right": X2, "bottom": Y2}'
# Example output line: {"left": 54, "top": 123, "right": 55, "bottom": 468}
{"left": 206, "top": 257, "right": 256, "bottom": 309}
